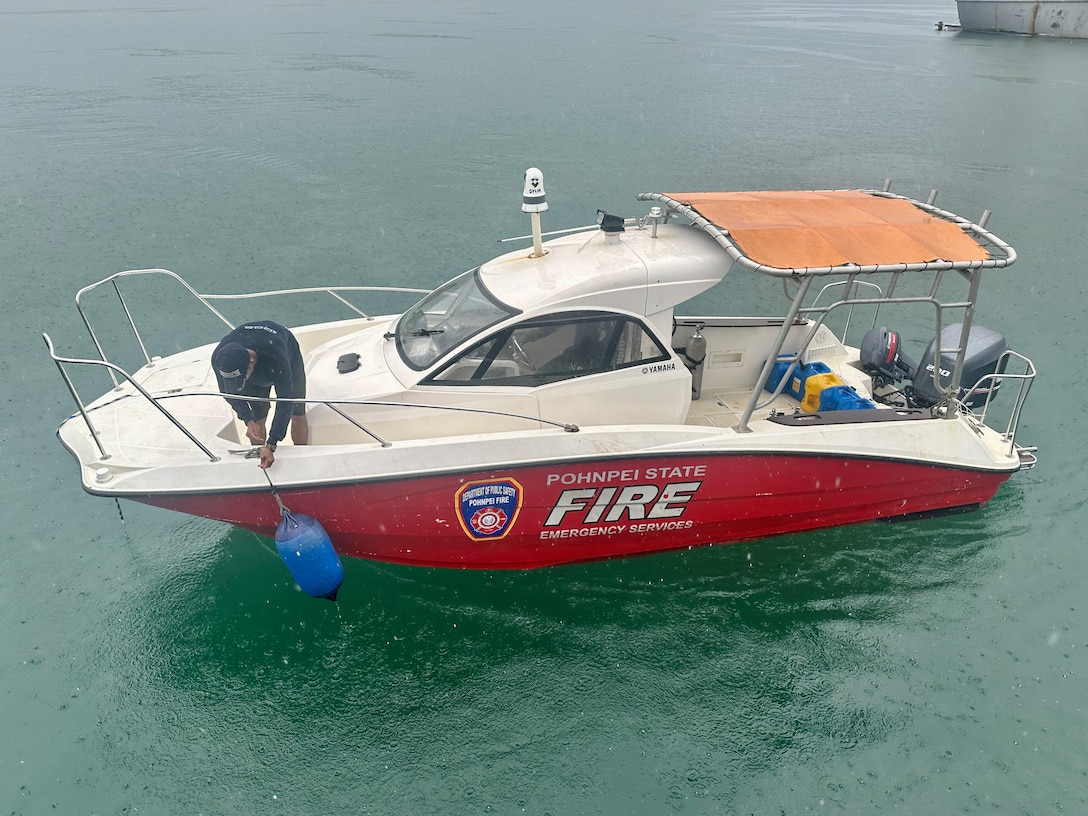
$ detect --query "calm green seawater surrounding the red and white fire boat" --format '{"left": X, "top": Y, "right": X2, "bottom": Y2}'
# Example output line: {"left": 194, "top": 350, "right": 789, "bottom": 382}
{"left": 0, "top": 0, "right": 1088, "bottom": 816}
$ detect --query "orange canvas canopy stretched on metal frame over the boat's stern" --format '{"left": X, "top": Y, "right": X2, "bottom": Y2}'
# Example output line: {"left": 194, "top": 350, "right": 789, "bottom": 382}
{"left": 665, "top": 190, "right": 990, "bottom": 269}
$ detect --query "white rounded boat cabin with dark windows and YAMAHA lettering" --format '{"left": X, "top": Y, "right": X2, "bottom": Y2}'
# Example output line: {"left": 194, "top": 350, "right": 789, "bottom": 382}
{"left": 299, "top": 220, "right": 730, "bottom": 444}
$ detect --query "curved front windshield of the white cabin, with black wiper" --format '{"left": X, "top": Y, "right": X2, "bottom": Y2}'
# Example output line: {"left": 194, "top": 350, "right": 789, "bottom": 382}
{"left": 396, "top": 269, "right": 517, "bottom": 370}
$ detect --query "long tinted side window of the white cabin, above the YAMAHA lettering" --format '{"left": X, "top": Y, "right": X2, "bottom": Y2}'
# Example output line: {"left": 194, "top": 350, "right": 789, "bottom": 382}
{"left": 424, "top": 312, "right": 669, "bottom": 386}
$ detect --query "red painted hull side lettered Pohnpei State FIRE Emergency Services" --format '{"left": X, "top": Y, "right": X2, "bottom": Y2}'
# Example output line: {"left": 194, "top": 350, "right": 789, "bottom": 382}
{"left": 129, "top": 454, "right": 1014, "bottom": 569}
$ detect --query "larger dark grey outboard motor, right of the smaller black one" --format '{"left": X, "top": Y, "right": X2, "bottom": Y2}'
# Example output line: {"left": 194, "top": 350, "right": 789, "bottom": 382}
{"left": 913, "top": 323, "right": 1009, "bottom": 408}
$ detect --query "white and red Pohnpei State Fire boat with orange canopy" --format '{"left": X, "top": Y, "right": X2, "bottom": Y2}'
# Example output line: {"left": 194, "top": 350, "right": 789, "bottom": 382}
{"left": 46, "top": 174, "right": 1035, "bottom": 569}
